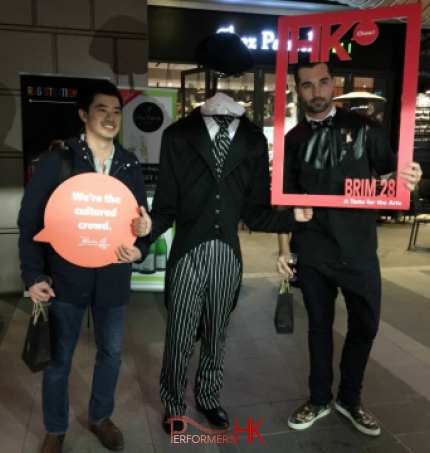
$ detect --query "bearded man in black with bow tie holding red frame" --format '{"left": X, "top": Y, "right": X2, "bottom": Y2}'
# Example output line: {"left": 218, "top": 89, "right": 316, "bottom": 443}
{"left": 278, "top": 63, "right": 422, "bottom": 436}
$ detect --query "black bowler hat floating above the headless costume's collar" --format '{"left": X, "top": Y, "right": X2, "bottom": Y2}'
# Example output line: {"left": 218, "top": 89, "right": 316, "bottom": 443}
{"left": 195, "top": 33, "right": 254, "bottom": 76}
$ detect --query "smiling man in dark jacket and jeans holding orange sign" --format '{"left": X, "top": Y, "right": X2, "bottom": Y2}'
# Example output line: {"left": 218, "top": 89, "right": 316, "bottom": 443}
{"left": 18, "top": 81, "right": 148, "bottom": 453}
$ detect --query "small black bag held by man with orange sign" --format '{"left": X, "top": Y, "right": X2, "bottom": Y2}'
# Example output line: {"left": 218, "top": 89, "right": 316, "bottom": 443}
{"left": 21, "top": 303, "right": 51, "bottom": 373}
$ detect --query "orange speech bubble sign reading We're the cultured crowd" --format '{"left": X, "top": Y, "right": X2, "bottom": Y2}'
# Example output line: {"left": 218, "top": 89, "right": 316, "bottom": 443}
{"left": 34, "top": 173, "right": 139, "bottom": 267}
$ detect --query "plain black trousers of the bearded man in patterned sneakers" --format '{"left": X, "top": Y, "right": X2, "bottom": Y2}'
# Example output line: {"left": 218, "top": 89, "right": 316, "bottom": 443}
{"left": 298, "top": 256, "right": 381, "bottom": 405}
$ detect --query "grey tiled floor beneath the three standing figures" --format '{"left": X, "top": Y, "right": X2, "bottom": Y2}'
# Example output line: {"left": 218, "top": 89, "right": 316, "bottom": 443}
{"left": 0, "top": 224, "right": 430, "bottom": 453}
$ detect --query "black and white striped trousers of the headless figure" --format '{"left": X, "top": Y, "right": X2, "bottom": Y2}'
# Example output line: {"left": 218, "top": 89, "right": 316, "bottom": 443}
{"left": 160, "top": 239, "right": 241, "bottom": 415}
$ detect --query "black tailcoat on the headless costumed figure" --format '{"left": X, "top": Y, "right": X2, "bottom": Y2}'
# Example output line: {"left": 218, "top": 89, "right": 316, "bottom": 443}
{"left": 151, "top": 108, "right": 297, "bottom": 268}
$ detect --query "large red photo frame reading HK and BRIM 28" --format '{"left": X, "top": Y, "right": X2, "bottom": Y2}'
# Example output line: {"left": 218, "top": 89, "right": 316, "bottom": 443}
{"left": 272, "top": 3, "right": 421, "bottom": 210}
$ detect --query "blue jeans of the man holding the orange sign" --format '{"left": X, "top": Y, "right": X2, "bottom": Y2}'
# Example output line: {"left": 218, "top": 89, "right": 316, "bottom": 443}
{"left": 42, "top": 301, "right": 126, "bottom": 434}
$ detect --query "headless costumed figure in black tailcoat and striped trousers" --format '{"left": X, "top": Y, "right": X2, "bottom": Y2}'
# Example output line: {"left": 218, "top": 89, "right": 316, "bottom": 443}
{"left": 151, "top": 93, "right": 296, "bottom": 415}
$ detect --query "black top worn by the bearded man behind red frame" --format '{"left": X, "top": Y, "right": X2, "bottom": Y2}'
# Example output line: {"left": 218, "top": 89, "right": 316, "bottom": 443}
{"left": 284, "top": 108, "right": 397, "bottom": 264}
